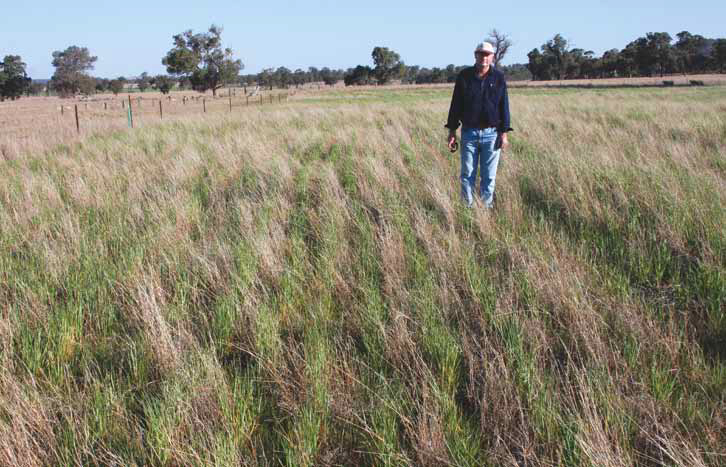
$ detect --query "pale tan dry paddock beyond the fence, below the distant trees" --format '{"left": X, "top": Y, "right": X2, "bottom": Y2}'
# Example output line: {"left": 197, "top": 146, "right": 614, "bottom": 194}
{"left": 0, "top": 74, "right": 726, "bottom": 157}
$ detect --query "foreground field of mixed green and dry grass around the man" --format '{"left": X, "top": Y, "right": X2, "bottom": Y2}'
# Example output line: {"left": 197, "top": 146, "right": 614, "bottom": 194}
{"left": 0, "top": 82, "right": 726, "bottom": 466}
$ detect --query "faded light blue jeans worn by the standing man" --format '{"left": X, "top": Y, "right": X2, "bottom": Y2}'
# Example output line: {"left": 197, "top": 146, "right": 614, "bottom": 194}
{"left": 461, "top": 127, "right": 500, "bottom": 208}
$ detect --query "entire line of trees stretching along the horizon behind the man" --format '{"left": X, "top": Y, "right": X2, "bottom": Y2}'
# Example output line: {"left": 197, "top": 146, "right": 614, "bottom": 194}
{"left": 5, "top": 25, "right": 726, "bottom": 100}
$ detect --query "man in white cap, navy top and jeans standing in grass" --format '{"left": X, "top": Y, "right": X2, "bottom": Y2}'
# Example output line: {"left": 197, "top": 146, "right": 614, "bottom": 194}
{"left": 446, "top": 42, "right": 512, "bottom": 208}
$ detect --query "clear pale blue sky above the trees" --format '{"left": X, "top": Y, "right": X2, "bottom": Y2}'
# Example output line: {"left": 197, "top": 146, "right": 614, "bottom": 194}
{"left": 0, "top": 0, "right": 726, "bottom": 78}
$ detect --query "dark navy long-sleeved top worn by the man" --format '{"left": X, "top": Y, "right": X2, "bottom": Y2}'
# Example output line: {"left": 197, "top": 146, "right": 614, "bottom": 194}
{"left": 446, "top": 66, "right": 512, "bottom": 134}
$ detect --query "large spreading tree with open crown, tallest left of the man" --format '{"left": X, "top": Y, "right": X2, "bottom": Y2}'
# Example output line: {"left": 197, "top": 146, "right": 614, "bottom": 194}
{"left": 161, "top": 24, "right": 243, "bottom": 96}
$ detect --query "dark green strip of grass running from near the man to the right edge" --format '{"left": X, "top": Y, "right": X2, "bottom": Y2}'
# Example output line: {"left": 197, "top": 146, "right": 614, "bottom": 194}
{"left": 519, "top": 177, "right": 726, "bottom": 362}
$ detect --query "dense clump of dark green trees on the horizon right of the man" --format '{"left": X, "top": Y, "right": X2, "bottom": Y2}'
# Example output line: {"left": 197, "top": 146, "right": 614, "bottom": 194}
{"left": 527, "top": 31, "right": 726, "bottom": 80}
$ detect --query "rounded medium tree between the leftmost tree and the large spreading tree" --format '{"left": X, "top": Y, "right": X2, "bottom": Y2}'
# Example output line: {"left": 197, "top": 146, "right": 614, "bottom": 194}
{"left": 51, "top": 45, "right": 98, "bottom": 97}
